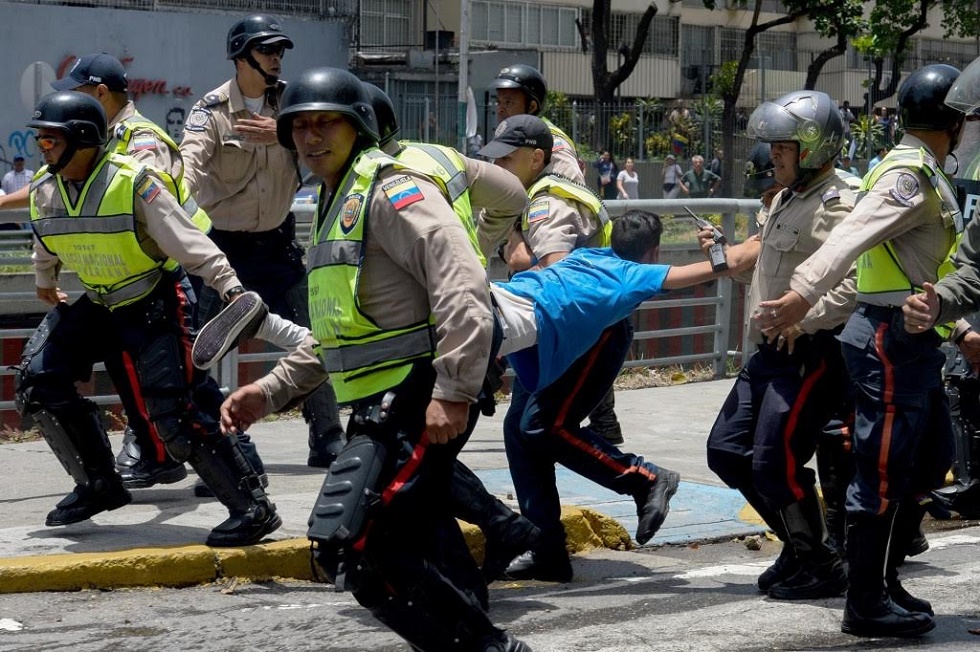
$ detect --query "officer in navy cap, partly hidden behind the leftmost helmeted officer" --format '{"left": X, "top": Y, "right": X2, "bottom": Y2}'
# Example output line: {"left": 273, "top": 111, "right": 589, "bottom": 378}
{"left": 51, "top": 53, "right": 218, "bottom": 489}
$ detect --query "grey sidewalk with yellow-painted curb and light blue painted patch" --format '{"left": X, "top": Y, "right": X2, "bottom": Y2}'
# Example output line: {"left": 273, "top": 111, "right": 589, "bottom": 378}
{"left": 0, "top": 379, "right": 761, "bottom": 592}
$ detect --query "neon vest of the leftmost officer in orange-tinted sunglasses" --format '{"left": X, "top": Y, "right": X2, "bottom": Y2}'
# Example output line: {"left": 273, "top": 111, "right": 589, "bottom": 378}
{"left": 31, "top": 153, "right": 178, "bottom": 309}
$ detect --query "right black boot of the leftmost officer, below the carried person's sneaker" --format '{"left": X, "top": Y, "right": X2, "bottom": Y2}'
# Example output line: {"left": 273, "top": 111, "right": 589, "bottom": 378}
{"left": 188, "top": 433, "right": 282, "bottom": 547}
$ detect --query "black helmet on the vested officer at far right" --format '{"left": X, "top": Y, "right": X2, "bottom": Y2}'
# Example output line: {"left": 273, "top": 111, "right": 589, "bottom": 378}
{"left": 898, "top": 63, "right": 963, "bottom": 131}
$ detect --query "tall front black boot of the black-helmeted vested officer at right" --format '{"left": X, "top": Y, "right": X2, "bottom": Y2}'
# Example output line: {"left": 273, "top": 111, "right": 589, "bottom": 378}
{"left": 841, "top": 508, "right": 936, "bottom": 636}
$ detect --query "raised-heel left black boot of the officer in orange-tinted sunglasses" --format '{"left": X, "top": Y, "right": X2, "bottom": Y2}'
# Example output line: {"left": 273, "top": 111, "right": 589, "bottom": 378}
{"left": 32, "top": 401, "right": 133, "bottom": 526}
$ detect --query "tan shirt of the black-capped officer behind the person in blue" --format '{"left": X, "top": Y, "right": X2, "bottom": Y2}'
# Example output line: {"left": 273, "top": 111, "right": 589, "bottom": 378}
{"left": 524, "top": 165, "right": 602, "bottom": 260}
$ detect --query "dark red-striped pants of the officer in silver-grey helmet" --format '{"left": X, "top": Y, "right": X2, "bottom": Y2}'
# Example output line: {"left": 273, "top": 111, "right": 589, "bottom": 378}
{"left": 707, "top": 331, "right": 846, "bottom": 510}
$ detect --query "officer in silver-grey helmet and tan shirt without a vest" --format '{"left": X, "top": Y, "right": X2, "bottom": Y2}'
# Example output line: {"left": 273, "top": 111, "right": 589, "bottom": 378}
{"left": 707, "top": 91, "right": 855, "bottom": 600}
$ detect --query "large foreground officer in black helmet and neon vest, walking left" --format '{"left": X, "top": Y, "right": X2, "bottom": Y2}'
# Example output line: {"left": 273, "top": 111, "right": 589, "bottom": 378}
{"left": 222, "top": 68, "right": 528, "bottom": 652}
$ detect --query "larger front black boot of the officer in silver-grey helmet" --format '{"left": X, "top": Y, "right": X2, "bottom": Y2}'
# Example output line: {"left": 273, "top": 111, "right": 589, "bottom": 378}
{"left": 769, "top": 490, "right": 847, "bottom": 600}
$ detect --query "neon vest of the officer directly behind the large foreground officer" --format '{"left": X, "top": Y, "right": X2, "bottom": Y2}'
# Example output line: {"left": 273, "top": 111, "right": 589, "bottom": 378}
{"left": 395, "top": 142, "right": 487, "bottom": 268}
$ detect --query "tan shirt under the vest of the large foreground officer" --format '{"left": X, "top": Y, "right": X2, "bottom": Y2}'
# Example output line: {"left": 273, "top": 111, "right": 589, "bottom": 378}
{"left": 259, "top": 169, "right": 493, "bottom": 409}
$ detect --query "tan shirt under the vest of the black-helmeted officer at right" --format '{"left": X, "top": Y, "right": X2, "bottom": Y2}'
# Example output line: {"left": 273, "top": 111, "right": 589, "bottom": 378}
{"left": 790, "top": 134, "right": 954, "bottom": 305}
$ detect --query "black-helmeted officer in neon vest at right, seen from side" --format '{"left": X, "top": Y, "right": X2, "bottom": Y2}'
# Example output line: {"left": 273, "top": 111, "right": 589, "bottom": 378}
{"left": 760, "top": 64, "right": 964, "bottom": 636}
